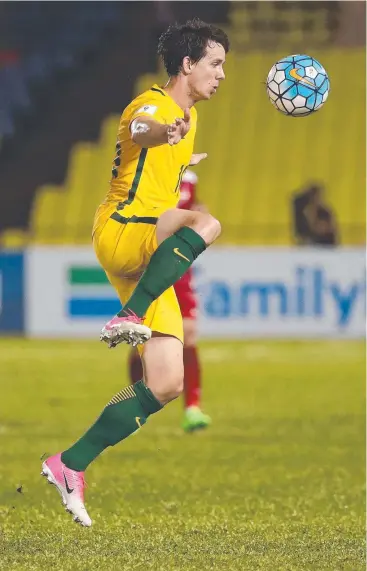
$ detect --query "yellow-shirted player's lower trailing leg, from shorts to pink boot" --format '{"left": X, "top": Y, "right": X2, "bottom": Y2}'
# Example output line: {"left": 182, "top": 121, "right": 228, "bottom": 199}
{"left": 42, "top": 282, "right": 183, "bottom": 526}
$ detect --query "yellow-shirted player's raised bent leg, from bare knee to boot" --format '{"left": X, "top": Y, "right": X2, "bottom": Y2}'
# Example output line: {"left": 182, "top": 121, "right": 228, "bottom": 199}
{"left": 101, "top": 209, "right": 221, "bottom": 346}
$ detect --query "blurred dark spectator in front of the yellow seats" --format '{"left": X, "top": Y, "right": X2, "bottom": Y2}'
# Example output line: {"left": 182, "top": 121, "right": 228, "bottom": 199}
{"left": 292, "top": 183, "right": 338, "bottom": 246}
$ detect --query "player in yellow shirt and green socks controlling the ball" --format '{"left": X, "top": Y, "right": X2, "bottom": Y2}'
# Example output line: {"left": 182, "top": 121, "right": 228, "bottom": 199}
{"left": 42, "top": 19, "right": 229, "bottom": 526}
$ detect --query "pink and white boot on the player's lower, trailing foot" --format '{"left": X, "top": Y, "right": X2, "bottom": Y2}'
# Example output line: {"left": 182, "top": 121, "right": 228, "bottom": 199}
{"left": 41, "top": 453, "right": 92, "bottom": 527}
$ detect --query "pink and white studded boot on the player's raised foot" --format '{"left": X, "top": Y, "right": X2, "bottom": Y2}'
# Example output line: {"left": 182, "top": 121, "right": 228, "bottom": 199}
{"left": 100, "top": 311, "right": 152, "bottom": 349}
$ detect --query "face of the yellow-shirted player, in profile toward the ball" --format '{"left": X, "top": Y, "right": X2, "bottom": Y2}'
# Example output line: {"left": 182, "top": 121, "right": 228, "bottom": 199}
{"left": 189, "top": 42, "right": 226, "bottom": 101}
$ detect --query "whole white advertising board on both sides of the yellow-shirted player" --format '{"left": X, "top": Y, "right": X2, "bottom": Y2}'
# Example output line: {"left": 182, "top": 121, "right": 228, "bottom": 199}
{"left": 25, "top": 247, "right": 366, "bottom": 338}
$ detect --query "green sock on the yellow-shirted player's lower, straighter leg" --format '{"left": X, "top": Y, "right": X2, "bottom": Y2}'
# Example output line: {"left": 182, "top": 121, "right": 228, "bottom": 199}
{"left": 61, "top": 381, "right": 162, "bottom": 472}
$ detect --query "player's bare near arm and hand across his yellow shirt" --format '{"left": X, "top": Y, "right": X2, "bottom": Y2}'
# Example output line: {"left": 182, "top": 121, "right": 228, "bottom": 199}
{"left": 130, "top": 109, "right": 190, "bottom": 149}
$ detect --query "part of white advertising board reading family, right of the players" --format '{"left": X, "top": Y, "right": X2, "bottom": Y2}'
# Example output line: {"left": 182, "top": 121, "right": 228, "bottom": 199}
{"left": 196, "top": 248, "right": 366, "bottom": 338}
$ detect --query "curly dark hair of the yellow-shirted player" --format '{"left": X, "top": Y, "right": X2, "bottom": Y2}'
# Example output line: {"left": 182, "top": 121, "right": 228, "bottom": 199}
{"left": 158, "top": 18, "right": 229, "bottom": 76}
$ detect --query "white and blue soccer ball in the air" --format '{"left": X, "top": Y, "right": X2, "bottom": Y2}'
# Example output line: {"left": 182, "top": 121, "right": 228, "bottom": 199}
{"left": 266, "top": 55, "right": 330, "bottom": 117}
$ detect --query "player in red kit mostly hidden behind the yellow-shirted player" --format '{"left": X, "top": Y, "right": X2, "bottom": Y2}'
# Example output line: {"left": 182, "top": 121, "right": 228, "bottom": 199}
{"left": 129, "top": 170, "right": 211, "bottom": 432}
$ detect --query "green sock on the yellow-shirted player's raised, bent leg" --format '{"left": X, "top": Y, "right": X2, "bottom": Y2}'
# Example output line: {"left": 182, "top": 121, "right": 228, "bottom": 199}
{"left": 118, "top": 226, "right": 206, "bottom": 317}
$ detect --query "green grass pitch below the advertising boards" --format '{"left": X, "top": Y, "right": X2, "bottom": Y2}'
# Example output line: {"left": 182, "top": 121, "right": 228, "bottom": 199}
{"left": 0, "top": 339, "right": 365, "bottom": 571}
